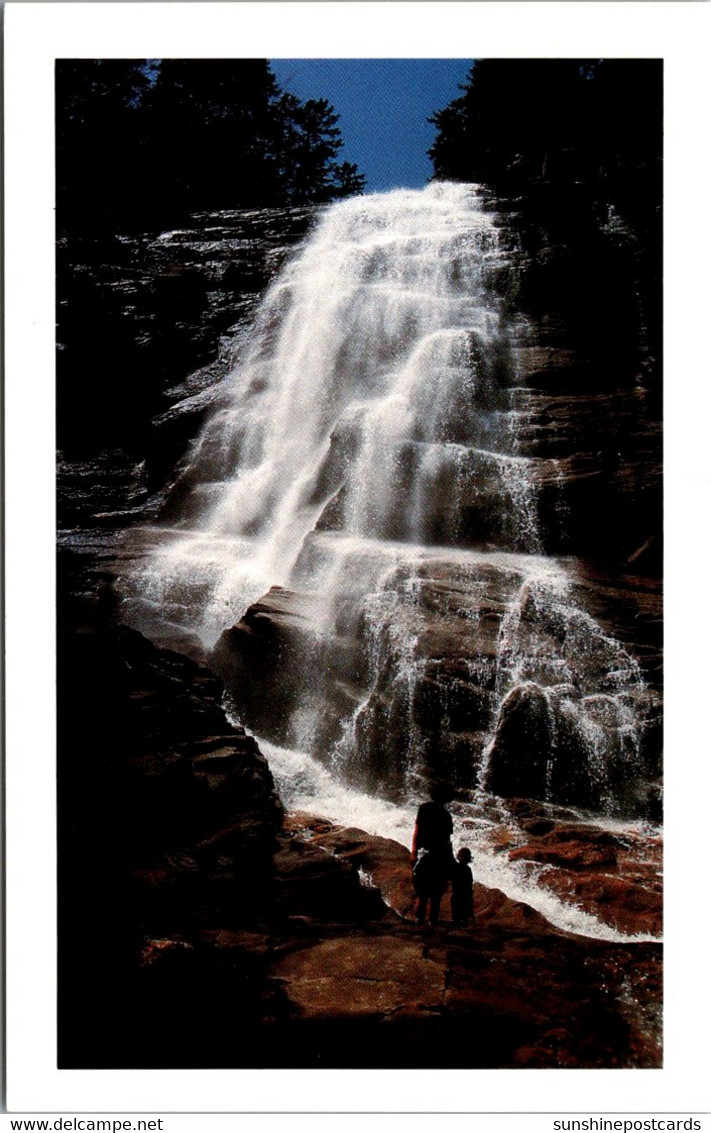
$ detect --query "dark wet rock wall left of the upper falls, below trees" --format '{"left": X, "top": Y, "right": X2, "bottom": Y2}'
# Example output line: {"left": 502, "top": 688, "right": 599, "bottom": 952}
{"left": 58, "top": 208, "right": 312, "bottom": 464}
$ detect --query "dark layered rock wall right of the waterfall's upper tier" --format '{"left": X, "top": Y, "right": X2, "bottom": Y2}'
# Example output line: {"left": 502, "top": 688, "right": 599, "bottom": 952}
{"left": 477, "top": 185, "right": 662, "bottom": 566}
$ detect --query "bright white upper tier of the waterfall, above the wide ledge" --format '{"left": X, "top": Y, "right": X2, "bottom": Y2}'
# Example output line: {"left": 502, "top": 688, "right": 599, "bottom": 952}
{"left": 126, "top": 186, "right": 525, "bottom": 641}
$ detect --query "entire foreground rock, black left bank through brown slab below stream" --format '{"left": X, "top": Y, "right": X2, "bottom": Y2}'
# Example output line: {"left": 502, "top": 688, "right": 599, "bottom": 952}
{"left": 59, "top": 629, "right": 661, "bottom": 1068}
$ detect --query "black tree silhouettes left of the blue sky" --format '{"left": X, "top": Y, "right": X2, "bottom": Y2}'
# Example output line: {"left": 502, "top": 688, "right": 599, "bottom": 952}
{"left": 55, "top": 59, "right": 365, "bottom": 231}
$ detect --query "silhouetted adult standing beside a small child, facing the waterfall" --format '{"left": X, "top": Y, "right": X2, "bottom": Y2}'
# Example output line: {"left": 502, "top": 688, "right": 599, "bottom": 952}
{"left": 410, "top": 786, "right": 454, "bottom": 925}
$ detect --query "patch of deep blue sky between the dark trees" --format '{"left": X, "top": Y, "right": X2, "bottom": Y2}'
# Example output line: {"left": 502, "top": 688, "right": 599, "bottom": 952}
{"left": 269, "top": 59, "right": 471, "bottom": 191}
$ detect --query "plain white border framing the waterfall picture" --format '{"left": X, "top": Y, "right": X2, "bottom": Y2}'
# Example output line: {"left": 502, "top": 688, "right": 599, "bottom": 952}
{"left": 6, "top": 2, "right": 711, "bottom": 1114}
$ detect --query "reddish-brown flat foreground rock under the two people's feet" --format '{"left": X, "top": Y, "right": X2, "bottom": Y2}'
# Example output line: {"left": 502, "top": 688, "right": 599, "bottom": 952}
{"left": 133, "top": 815, "right": 661, "bottom": 1068}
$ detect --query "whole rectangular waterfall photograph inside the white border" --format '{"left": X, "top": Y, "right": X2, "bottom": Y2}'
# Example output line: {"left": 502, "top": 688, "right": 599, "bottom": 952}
{"left": 48, "top": 55, "right": 665, "bottom": 1069}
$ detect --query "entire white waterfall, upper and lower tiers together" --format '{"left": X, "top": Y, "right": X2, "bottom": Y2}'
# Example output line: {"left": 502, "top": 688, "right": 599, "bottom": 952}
{"left": 123, "top": 184, "right": 646, "bottom": 938}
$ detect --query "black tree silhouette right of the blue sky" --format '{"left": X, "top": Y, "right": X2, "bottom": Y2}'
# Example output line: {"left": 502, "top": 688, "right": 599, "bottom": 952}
{"left": 428, "top": 59, "right": 662, "bottom": 225}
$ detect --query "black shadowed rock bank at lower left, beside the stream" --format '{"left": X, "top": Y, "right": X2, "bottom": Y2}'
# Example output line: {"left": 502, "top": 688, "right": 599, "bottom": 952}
{"left": 58, "top": 629, "right": 283, "bottom": 1066}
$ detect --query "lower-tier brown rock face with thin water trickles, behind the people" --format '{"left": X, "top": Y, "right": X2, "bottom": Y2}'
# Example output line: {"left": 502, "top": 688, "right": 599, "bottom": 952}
{"left": 212, "top": 555, "right": 660, "bottom": 817}
